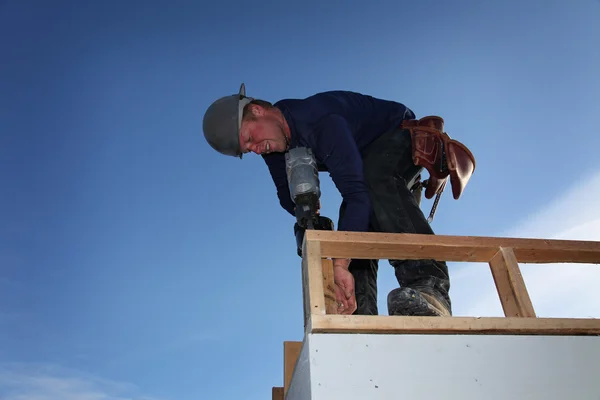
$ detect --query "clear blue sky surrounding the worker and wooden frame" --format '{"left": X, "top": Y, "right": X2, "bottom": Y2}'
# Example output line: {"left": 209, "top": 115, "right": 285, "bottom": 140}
{"left": 0, "top": 0, "right": 600, "bottom": 400}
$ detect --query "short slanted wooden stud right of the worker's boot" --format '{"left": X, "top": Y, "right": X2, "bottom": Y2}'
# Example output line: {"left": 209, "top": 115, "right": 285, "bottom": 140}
{"left": 489, "top": 247, "right": 535, "bottom": 317}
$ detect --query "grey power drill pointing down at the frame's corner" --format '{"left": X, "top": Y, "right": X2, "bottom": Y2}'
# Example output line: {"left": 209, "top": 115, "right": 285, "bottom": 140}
{"left": 285, "top": 147, "right": 334, "bottom": 257}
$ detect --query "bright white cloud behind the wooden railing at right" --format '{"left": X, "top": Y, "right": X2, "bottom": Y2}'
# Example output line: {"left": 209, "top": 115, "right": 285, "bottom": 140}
{"left": 451, "top": 173, "right": 600, "bottom": 318}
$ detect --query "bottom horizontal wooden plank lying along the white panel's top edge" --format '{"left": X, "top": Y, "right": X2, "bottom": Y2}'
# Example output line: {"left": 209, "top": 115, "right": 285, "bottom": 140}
{"left": 310, "top": 315, "right": 600, "bottom": 335}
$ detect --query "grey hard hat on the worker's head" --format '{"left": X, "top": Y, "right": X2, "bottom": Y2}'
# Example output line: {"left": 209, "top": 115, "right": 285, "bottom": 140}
{"left": 202, "top": 83, "right": 253, "bottom": 158}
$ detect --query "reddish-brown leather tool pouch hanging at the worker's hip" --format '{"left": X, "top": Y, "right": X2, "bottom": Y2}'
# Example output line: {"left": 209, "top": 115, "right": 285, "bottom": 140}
{"left": 401, "top": 116, "right": 475, "bottom": 200}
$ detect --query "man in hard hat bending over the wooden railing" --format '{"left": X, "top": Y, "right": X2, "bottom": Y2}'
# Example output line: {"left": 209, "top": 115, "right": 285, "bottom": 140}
{"left": 203, "top": 84, "right": 452, "bottom": 316}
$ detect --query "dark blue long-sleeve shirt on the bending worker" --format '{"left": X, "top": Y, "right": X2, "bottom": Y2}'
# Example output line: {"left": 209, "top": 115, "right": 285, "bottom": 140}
{"left": 262, "top": 91, "right": 415, "bottom": 232}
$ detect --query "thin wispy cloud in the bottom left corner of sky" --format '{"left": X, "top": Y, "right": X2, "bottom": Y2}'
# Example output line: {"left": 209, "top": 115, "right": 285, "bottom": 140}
{"left": 0, "top": 364, "right": 164, "bottom": 400}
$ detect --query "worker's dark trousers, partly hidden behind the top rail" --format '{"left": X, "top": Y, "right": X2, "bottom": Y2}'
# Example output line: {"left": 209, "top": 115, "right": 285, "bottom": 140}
{"left": 338, "top": 129, "right": 450, "bottom": 315}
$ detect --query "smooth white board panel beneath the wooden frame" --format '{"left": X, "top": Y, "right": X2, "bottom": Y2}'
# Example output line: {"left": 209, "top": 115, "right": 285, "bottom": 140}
{"left": 304, "top": 334, "right": 600, "bottom": 400}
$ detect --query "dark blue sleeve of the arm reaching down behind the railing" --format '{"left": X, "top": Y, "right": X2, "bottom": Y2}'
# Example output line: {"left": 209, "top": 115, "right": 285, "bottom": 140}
{"left": 311, "top": 114, "right": 371, "bottom": 232}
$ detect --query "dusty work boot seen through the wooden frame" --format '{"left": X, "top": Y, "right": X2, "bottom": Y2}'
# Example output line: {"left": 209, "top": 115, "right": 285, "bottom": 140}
{"left": 387, "top": 286, "right": 452, "bottom": 317}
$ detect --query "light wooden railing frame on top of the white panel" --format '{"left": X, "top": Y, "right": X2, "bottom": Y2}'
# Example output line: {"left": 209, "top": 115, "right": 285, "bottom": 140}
{"left": 302, "top": 230, "right": 600, "bottom": 335}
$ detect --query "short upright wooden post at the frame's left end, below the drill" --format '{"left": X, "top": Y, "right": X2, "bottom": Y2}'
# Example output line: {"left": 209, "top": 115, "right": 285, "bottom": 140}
{"left": 302, "top": 236, "right": 325, "bottom": 326}
